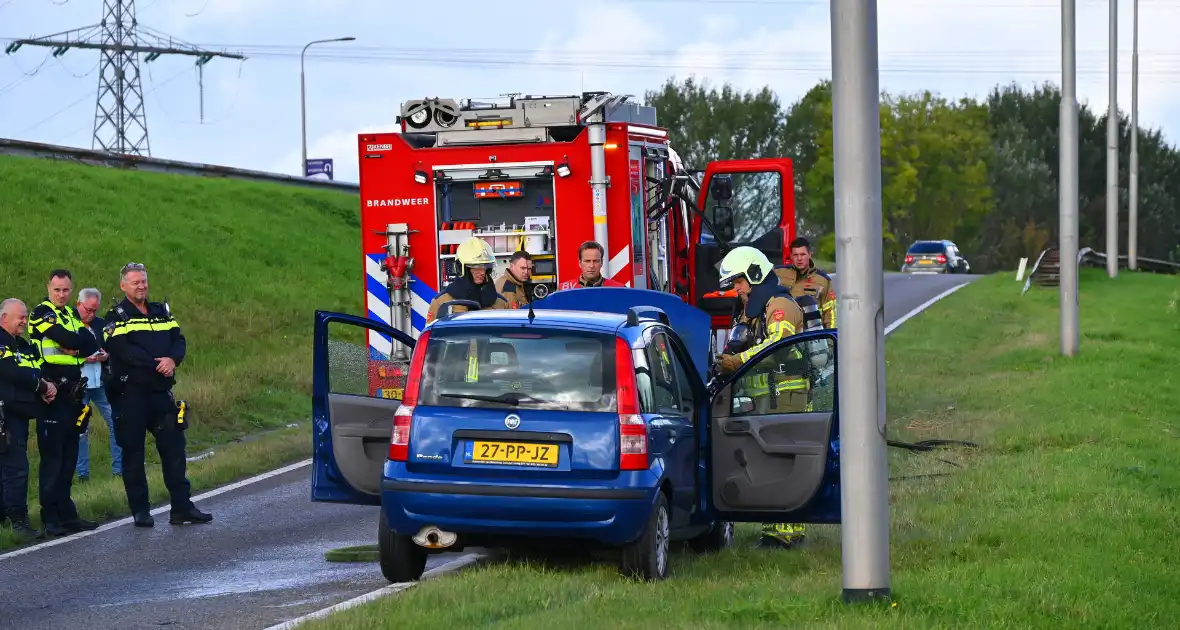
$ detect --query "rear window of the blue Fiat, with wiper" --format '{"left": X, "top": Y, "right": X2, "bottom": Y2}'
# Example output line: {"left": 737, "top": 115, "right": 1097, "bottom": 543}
{"left": 418, "top": 328, "right": 617, "bottom": 412}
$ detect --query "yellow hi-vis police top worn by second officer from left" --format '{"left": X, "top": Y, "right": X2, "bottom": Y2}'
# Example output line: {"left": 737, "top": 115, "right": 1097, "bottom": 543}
{"left": 28, "top": 300, "right": 98, "bottom": 383}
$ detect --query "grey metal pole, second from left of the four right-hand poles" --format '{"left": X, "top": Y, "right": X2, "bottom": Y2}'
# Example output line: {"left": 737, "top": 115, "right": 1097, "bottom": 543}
{"left": 1057, "top": 0, "right": 1079, "bottom": 356}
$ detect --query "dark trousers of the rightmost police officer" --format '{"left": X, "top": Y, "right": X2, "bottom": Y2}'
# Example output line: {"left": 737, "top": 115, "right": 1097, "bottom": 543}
{"left": 112, "top": 385, "right": 194, "bottom": 513}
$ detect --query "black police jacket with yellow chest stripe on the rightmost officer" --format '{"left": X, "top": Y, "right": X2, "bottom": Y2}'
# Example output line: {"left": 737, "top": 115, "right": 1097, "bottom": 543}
{"left": 103, "top": 298, "right": 188, "bottom": 392}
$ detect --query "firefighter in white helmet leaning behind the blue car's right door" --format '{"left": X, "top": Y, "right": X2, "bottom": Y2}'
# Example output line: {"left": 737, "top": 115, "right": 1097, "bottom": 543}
{"left": 717, "top": 247, "right": 809, "bottom": 549}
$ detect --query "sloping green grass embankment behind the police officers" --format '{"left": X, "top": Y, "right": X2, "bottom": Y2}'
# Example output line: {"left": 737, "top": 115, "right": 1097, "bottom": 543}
{"left": 0, "top": 156, "right": 360, "bottom": 549}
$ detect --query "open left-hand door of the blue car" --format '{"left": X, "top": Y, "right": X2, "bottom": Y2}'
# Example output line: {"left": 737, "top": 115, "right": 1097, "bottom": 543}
{"left": 312, "top": 310, "right": 414, "bottom": 505}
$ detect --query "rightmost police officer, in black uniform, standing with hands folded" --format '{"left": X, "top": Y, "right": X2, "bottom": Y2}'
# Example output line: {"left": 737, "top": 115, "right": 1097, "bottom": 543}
{"left": 104, "top": 263, "right": 214, "bottom": 527}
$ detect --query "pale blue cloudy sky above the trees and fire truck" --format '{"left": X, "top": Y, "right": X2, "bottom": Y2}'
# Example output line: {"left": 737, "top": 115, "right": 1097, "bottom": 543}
{"left": 0, "top": 0, "right": 1180, "bottom": 182}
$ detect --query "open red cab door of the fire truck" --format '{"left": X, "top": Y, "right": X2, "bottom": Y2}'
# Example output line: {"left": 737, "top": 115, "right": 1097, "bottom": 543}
{"left": 688, "top": 158, "right": 795, "bottom": 329}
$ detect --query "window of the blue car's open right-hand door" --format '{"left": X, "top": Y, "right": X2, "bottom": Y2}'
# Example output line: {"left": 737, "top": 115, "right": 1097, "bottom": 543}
{"left": 729, "top": 337, "right": 835, "bottom": 416}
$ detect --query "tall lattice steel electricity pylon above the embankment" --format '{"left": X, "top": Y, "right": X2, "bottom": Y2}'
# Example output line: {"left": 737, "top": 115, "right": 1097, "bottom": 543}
{"left": 5, "top": 0, "right": 245, "bottom": 156}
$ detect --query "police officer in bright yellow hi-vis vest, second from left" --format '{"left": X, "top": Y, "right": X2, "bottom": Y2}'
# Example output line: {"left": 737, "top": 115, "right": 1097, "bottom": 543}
{"left": 28, "top": 269, "right": 98, "bottom": 536}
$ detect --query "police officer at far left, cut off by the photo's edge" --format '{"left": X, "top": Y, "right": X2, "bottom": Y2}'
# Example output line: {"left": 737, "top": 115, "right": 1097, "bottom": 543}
{"left": 0, "top": 297, "right": 57, "bottom": 542}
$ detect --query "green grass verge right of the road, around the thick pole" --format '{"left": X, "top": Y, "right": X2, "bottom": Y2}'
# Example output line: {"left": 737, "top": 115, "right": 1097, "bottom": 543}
{"left": 299, "top": 270, "right": 1180, "bottom": 630}
